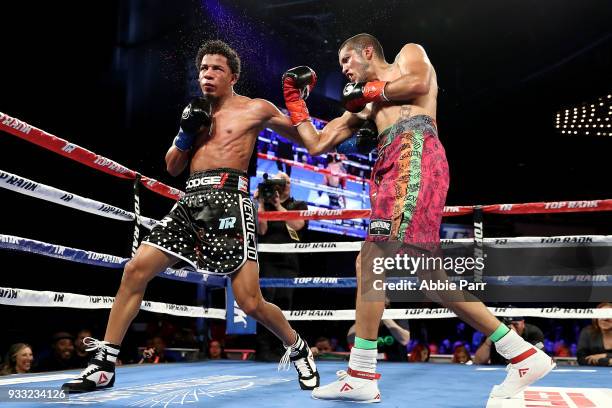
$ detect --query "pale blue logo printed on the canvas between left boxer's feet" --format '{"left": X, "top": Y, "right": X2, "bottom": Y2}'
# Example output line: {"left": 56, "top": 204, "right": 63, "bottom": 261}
{"left": 65, "top": 375, "right": 291, "bottom": 407}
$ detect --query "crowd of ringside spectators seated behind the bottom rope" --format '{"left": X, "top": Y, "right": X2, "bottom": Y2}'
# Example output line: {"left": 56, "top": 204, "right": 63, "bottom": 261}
{"left": 0, "top": 303, "right": 612, "bottom": 375}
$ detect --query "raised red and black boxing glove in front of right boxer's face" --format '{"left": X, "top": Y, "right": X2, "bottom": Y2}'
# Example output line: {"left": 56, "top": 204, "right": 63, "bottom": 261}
{"left": 283, "top": 66, "right": 317, "bottom": 126}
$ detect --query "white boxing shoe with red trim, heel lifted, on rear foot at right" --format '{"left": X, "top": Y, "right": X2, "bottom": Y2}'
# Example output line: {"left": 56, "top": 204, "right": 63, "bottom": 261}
{"left": 491, "top": 347, "right": 556, "bottom": 398}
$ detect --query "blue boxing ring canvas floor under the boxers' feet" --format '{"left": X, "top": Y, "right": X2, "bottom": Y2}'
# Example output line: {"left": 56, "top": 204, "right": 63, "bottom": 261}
{"left": 0, "top": 361, "right": 612, "bottom": 408}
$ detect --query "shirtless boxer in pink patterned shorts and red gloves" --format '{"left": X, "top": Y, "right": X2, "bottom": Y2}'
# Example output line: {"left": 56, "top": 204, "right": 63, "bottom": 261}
{"left": 283, "top": 34, "right": 554, "bottom": 402}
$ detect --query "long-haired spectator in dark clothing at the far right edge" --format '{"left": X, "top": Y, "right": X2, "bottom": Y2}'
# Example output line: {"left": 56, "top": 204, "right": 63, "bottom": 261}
{"left": 576, "top": 302, "right": 612, "bottom": 366}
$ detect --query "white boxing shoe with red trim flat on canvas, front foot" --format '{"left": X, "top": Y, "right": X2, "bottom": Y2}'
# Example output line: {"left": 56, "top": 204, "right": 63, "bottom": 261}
{"left": 312, "top": 368, "right": 380, "bottom": 403}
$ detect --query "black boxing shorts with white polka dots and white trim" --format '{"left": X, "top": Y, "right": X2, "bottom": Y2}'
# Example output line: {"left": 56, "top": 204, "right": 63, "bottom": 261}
{"left": 142, "top": 168, "right": 257, "bottom": 275}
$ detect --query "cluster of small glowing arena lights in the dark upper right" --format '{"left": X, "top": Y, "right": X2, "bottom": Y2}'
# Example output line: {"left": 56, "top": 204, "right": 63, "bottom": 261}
{"left": 554, "top": 94, "right": 612, "bottom": 136}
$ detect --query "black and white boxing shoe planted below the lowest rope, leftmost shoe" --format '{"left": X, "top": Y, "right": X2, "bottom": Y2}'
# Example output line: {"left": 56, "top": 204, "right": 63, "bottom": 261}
{"left": 62, "top": 337, "right": 119, "bottom": 393}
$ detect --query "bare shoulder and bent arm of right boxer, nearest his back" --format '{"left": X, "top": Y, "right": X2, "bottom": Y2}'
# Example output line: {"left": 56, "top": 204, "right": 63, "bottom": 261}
{"left": 385, "top": 44, "right": 433, "bottom": 101}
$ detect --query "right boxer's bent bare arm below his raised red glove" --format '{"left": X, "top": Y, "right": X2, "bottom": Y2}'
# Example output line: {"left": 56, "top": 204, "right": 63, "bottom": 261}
{"left": 297, "top": 112, "right": 363, "bottom": 156}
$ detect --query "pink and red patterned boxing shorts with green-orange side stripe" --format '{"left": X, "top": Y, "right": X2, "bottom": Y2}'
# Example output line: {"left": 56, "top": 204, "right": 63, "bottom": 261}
{"left": 366, "top": 115, "right": 449, "bottom": 243}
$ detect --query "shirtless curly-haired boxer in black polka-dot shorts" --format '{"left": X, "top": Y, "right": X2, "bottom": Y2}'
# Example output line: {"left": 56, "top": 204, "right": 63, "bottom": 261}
{"left": 63, "top": 41, "right": 319, "bottom": 392}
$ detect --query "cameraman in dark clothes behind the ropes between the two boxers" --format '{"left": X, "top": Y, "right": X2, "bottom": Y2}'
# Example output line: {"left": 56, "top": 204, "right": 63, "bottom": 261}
{"left": 254, "top": 173, "right": 308, "bottom": 361}
